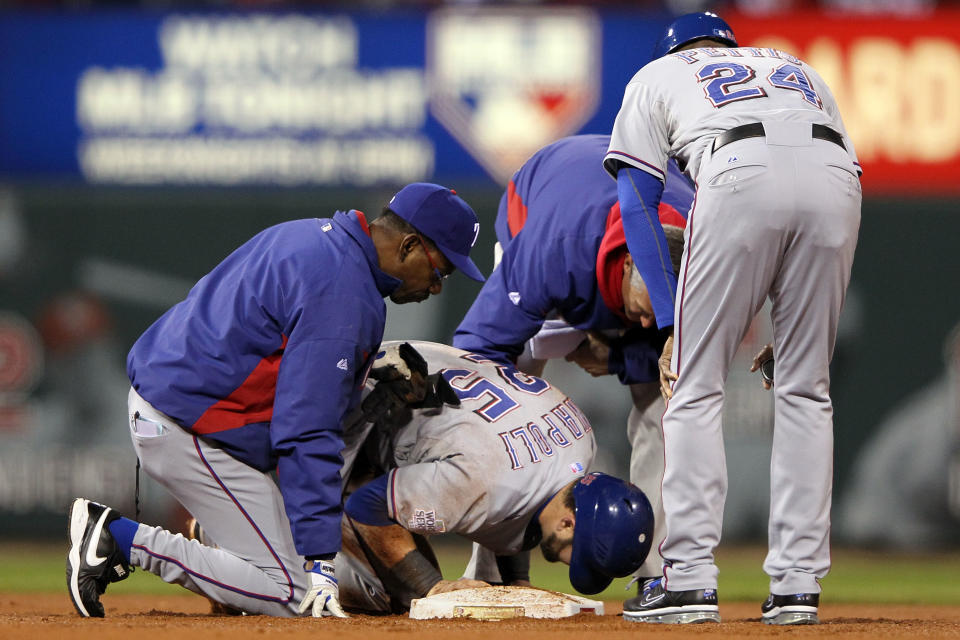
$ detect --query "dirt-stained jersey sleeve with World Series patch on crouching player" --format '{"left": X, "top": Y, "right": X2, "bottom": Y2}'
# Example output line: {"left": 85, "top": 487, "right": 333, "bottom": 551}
{"left": 387, "top": 455, "right": 490, "bottom": 535}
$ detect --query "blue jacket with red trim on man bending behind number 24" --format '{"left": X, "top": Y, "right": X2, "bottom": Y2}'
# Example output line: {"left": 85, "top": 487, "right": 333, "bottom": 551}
{"left": 453, "top": 135, "right": 693, "bottom": 384}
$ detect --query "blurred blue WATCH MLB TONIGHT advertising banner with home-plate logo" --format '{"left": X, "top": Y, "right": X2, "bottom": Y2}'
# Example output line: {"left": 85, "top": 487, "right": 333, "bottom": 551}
{"left": 0, "top": 8, "right": 668, "bottom": 186}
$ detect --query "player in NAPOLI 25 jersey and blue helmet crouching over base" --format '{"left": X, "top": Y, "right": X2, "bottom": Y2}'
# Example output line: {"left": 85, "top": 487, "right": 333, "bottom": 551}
{"left": 337, "top": 342, "right": 653, "bottom": 612}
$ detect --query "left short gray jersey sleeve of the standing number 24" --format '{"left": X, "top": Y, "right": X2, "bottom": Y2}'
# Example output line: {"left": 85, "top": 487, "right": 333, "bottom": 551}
{"left": 603, "top": 78, "right": 670, "bottom": 181}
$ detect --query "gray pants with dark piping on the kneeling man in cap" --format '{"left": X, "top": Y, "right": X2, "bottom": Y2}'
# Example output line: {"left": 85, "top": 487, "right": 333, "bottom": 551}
{"left": 127, "top": 389, "right": 308, "bottom": 616}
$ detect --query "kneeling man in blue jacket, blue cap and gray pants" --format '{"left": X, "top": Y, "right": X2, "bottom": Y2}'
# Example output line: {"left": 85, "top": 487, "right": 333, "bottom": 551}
{"left": 67, "top": 183, "right": 483, "bottom": 616}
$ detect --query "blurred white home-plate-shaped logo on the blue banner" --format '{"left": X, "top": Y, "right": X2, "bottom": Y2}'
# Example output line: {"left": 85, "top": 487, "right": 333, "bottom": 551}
{"left": 426, "top": 7, "right": 601, "bottom": 184}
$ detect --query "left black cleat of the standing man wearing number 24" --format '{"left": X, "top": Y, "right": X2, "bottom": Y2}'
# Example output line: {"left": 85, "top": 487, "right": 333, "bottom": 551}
{"left": 623, "top": 578, "right": 720, "bottom": 624}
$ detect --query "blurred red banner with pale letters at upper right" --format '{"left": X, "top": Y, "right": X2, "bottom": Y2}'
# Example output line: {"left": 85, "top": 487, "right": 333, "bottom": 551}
{"left": 725, "top": 11, "right": 960, "bottom": 195}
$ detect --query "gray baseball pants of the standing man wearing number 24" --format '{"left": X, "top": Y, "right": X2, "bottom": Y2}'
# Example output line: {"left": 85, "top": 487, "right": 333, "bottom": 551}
{"left": 661, "top": 123, "right": 861, "bottom": 595}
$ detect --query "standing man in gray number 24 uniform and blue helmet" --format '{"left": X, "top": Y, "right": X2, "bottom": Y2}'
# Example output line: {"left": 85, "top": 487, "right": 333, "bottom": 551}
{"left": 604, "top": 13, "right": 861, "bottom": 624}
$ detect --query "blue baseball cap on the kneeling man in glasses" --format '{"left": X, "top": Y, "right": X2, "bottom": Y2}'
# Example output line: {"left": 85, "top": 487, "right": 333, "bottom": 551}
{"left": 387, "top": 182, "right": 484, "bottom": 282}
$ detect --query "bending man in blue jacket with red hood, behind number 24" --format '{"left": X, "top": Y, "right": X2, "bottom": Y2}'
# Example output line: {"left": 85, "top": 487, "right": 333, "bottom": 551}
{"left": 453, "top": 135, "right": 693, "bottom": 596}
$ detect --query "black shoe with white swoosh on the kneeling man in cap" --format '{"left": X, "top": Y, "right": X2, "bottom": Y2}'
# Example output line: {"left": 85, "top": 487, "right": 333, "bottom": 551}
{"left": 67, "top": 498, "right": 131, "bottom": 618}
